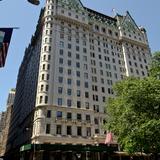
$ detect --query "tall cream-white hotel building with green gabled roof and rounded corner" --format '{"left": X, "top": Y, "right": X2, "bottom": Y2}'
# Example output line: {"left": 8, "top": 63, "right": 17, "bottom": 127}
{"left": 5, "top": 0, "right": 151, "bottom": 159}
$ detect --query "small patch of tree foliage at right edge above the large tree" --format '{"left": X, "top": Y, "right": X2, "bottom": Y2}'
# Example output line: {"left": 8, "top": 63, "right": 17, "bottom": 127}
{"left": 150, "top": 51, "right": 160, "bottom": 79}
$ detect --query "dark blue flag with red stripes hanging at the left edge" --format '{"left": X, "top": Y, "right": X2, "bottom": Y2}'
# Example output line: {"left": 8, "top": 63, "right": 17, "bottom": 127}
{"left": 0, "top": 28, "right": 13, "bottom": 68}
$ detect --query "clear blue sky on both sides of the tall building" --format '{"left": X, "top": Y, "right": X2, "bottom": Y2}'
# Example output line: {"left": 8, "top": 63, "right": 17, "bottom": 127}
{"left": 0, "top": 0, "right": 160, "bottom": 111}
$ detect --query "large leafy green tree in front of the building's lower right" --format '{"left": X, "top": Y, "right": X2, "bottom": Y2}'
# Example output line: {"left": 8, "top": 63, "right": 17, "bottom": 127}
{"left": 105, "top": 77, "right": 160, "bottom": 158}
